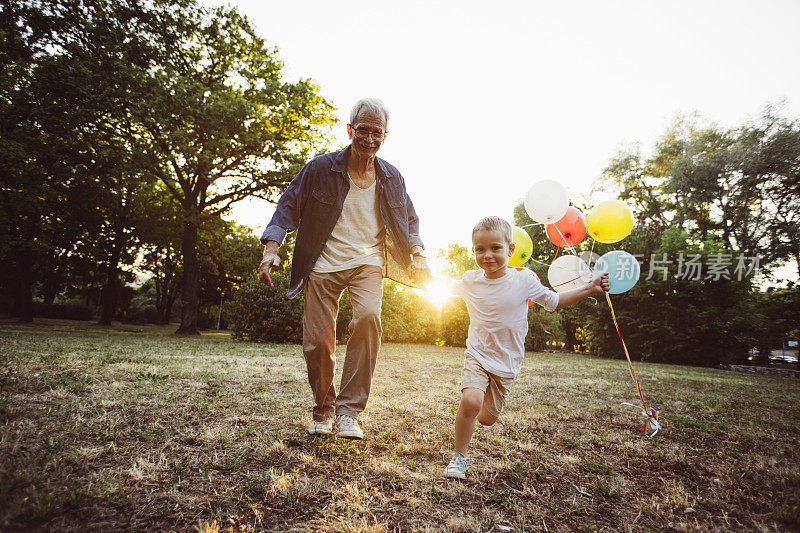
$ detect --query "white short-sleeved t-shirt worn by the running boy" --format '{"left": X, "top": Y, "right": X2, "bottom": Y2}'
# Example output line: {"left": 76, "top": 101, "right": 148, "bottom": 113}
{"left": 452, "top": 267, "right": 559, "bottom": 378}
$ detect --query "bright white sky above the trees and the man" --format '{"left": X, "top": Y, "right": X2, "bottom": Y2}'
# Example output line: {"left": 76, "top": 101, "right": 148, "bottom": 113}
{"left": 220, "top": 0, "right": 800, "bottom": 272}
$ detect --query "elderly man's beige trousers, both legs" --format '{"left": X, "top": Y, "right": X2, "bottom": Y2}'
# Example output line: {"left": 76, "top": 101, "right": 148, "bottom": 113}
{"left": 303, "top": 265, "right": 383, "bottom": 422}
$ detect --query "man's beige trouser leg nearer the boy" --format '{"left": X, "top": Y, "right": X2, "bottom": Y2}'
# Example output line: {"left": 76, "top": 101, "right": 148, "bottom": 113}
{"left": 336, "top": 265, "right": 383, "bottom": 418}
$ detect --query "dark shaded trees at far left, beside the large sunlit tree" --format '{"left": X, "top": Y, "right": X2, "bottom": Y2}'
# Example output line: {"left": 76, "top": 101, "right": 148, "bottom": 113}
{"left": 0, "top": 0, "right": 175, "bottom": 323}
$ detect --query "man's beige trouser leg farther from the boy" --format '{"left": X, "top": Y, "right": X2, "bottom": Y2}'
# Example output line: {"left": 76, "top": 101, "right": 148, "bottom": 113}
{"left": 303, "top": 272, "right": 344, "bottom": 424}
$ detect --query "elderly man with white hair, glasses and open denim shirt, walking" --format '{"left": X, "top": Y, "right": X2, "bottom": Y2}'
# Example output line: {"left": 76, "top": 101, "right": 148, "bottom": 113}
{"left": 258, "top": 99, "right": 430, "bottom": 439}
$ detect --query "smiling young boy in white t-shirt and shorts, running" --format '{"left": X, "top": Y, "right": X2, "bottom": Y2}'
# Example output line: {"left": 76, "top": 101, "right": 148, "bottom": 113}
{"left": 444, "top": 217, "right": 609, "bottom": 479}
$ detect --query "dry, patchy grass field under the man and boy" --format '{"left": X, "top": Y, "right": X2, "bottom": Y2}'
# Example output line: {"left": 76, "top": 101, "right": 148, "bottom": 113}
{"left": 0, "top": 320, "right": 800, "bottom": 532}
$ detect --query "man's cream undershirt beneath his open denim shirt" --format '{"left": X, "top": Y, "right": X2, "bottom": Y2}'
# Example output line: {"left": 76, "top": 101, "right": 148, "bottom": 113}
{"left": 314, "top": 176, "right": 386, "bottom": 273}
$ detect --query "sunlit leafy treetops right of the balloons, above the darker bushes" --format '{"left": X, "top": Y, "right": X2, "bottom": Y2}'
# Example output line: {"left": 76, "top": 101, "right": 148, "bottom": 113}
{"left": 598, "top": 108, "right": 800, "bottom": 276}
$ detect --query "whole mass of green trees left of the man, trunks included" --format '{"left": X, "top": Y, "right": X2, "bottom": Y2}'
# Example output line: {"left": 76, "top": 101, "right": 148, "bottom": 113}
{"left": 0, "top": 0, "right": 334, "bottom": 333}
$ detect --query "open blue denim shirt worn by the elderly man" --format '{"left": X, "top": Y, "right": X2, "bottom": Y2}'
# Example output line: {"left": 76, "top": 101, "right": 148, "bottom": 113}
{"left": 261, "top": 147, "right": 423, "bottom": 298}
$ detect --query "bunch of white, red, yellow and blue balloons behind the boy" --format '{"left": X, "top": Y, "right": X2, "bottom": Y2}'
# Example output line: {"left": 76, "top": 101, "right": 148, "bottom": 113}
{"left": 508, "top": 180, "right": 641, "bottom": 294}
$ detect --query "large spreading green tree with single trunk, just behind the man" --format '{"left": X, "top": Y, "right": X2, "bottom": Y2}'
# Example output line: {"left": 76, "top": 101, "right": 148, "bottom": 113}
{"left": 130, "top": 5, "right": 333, "bottom": 334}
